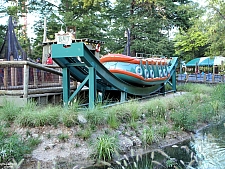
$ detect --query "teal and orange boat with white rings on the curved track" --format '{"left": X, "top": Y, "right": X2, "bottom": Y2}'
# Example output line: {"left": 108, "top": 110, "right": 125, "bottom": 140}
{"left": 100, "top": 54, "right": 170, "bottom": 86}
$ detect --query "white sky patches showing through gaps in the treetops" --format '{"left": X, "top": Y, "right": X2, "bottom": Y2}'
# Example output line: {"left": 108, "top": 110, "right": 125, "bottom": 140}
{"left": 0, "top": 0, "right": 205, "bottom": 38}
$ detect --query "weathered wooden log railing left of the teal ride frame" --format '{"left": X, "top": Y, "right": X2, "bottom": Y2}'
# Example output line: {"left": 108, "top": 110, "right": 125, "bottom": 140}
{"left": 0, "top": 61, "right": 65, "bottom": 98}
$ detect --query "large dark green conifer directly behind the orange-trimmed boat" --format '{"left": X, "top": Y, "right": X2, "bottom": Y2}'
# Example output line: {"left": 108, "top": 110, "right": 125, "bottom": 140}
{"left": 106, "top": 0, "right": 200, "bottom": 56}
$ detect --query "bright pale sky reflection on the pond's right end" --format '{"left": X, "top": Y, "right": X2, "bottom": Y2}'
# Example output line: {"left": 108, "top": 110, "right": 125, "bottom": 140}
{"left": 191, "top": 122, "right": 225, "bottom": 169}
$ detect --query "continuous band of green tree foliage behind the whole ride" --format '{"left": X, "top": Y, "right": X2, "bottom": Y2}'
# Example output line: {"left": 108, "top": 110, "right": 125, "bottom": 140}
{"left": 0, "top": 0, "right": 225, "bottom": 60}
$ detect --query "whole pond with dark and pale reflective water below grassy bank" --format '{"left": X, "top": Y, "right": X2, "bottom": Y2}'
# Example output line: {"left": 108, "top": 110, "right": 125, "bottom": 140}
{"left": 88, "top": 121, "right": 225, "bottom": 169}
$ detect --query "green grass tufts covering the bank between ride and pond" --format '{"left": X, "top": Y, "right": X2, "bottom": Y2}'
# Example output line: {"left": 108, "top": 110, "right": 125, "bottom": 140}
{"left": 0, "top": 84, "right": 225, "bottom": 165}
